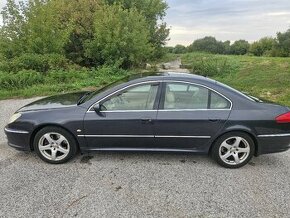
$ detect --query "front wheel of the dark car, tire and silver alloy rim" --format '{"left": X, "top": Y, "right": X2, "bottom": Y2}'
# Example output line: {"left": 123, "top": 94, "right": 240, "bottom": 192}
{"left": 33, "top": 126, "right": 77, "bottom": 164}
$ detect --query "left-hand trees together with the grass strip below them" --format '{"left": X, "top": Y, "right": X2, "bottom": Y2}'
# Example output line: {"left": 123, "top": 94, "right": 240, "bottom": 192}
{"left": 0, "top": 0, "right": 169, "bottom": 99}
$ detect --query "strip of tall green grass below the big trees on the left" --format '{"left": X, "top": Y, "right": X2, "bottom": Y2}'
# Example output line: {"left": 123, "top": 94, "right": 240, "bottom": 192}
{"left": 0, "top": 67, "right": 131, "bottom": 99}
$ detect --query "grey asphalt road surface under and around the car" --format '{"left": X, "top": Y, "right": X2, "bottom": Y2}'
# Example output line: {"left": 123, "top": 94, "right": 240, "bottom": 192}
{"left": 0, "top": 99, "right": 290, "bottom": 217}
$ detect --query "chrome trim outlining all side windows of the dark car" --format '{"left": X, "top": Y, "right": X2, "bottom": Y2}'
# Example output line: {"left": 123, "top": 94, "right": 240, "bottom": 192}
{"left": 86, "top": 79, "right": 233, "bottom": 113}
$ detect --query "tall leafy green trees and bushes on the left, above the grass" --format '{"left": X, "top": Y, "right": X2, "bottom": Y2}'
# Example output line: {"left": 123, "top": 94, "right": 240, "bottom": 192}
{"left": 0, "top": 0, "right": 169, "bottom": 71}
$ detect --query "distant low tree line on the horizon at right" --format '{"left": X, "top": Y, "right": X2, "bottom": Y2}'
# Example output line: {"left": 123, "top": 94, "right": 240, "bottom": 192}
{"left": 167, "top": 29, "right": 290, "bottom": 57}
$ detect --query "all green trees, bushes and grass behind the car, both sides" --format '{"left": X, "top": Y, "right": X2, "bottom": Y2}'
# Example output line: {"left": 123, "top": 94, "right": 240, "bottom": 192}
{"left": 0, "top": 0, "right": 290, "bottom": 106}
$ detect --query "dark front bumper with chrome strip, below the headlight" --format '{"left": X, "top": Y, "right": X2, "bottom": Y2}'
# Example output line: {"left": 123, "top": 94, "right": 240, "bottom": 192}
{"left": 4, "top": 127, "right": 31, "bottom": 151}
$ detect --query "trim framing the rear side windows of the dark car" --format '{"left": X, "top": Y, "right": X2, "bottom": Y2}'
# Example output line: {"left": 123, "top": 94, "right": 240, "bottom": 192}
{"left": 158, "top": 80, "right": 233, "bottom": 112}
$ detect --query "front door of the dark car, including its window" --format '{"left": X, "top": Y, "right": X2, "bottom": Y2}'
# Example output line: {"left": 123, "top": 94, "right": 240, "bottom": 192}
{"left": 84, "top": 82, "right": 160, "bottom": 150}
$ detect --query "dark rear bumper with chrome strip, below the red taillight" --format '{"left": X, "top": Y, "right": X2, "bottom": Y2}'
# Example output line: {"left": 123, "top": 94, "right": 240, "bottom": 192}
{"left": 257, "top": 133, "right": 290, "bottom": 155}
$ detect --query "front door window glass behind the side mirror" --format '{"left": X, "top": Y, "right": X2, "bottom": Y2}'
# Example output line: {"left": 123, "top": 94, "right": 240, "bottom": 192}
{"left": 101, "top": 84, "right": 158, "bottom": 111}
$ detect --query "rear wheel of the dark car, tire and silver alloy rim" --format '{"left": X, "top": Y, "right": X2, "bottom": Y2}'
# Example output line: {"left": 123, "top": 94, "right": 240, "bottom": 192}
{"left": 211, "top": 132, "right": 255, "bottom": 168}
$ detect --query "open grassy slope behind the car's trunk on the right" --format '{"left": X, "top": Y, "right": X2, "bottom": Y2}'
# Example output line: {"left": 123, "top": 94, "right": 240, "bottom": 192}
{"left": 166, "top": 53, "right": 290, "bottom": 106}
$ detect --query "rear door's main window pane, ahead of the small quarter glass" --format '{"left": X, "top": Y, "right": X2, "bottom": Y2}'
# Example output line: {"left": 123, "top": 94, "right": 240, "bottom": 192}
{"left": 164, "top": 83, "right": 209, "bottom": 109}
